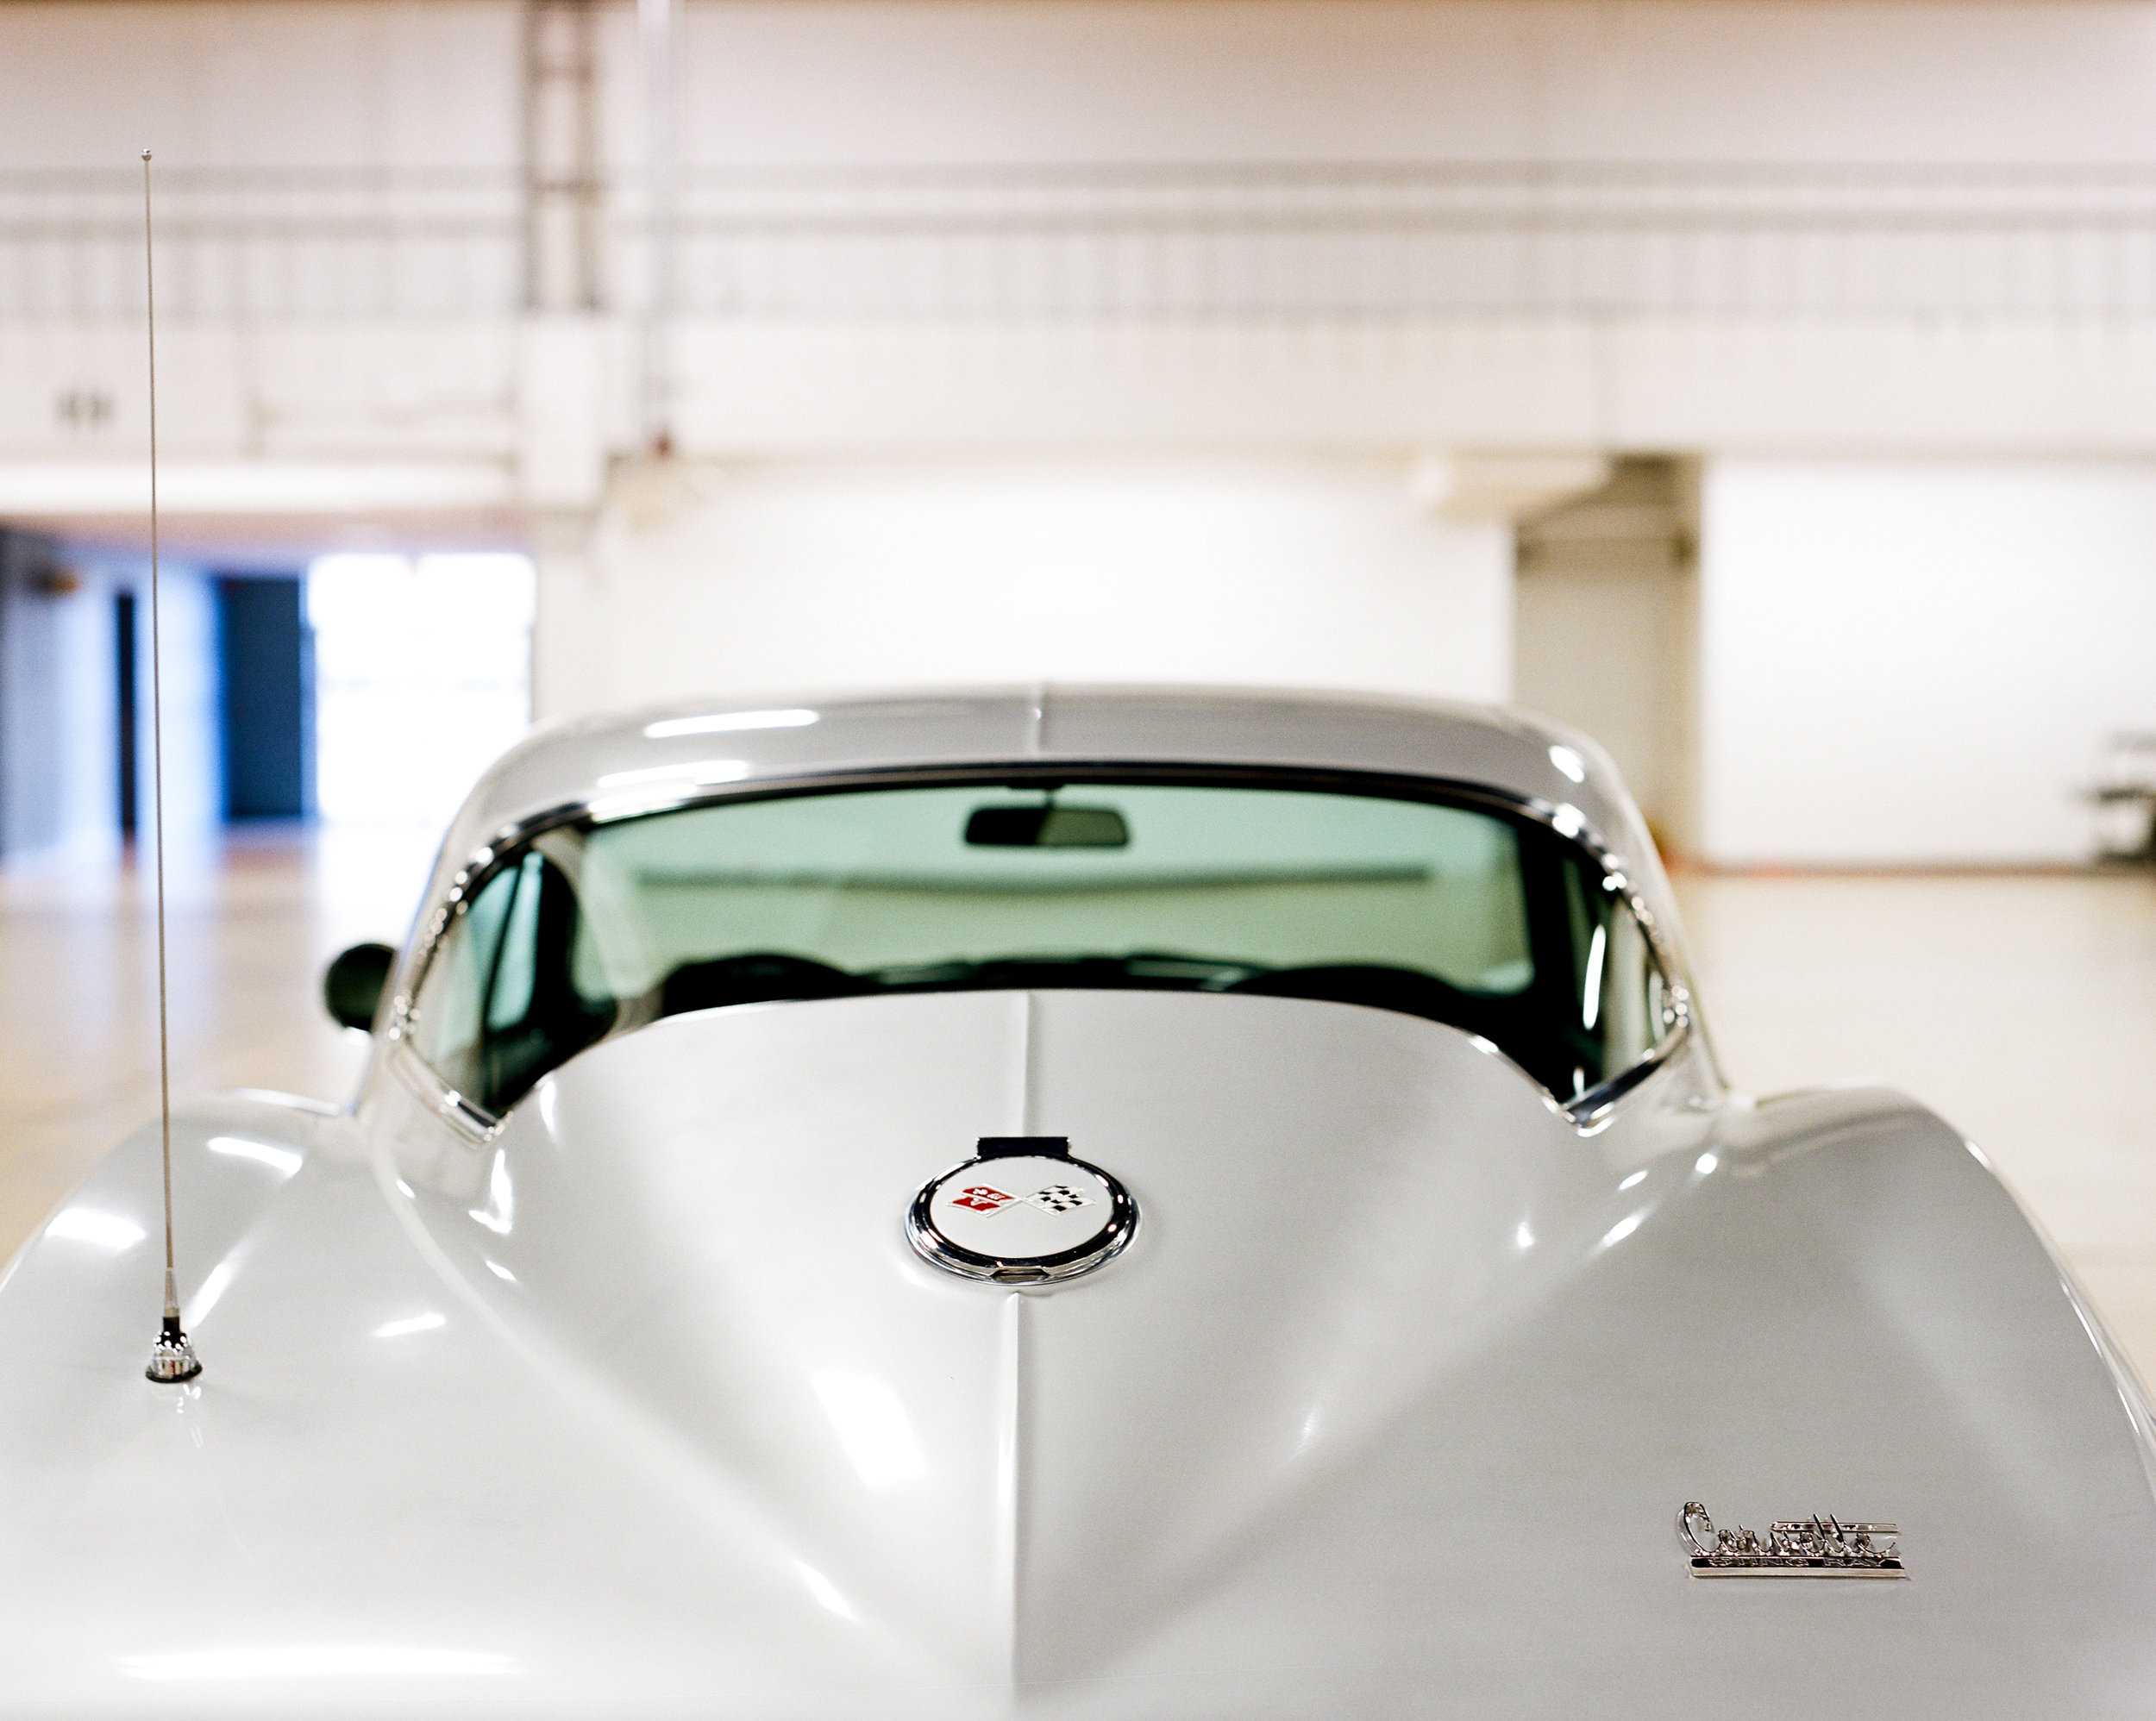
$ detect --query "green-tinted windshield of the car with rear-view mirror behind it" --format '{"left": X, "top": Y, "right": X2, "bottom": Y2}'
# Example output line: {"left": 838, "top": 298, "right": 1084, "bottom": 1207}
{"left": 414, "top": 783, "right": 1669, "bottom": 1111}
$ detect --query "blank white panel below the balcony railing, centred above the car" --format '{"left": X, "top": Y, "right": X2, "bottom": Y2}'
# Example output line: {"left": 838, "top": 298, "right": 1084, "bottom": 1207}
{"left": 675, "top": 317, "right": 1613, "bottom": 457}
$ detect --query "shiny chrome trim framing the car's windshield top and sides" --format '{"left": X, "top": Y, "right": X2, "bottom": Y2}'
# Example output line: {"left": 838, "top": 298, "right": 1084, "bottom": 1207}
{"left": 382, "top": 757, "right": 1712, "bottom": 1143}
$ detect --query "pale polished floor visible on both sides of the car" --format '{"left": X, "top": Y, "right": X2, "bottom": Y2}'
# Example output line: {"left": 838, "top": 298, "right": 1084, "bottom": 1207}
{"left": 0, "top": 830, "right": 2156, "bottom": 1378}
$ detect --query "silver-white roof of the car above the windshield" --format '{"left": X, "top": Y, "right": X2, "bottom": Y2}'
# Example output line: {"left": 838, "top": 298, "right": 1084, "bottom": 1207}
{"left": 429, "top": 685, "right": 1676, "bottom": 932}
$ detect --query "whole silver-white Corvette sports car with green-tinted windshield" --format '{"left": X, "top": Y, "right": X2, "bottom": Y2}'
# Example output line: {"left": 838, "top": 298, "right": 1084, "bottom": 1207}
{"left": 0, "top": 692, "right": 2156, "bottom": 1721}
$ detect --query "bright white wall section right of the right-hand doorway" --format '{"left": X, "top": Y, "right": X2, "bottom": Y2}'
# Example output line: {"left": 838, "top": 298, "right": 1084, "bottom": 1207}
{"left": 1699, "top": 460, "right": 2156, "bottom": 865}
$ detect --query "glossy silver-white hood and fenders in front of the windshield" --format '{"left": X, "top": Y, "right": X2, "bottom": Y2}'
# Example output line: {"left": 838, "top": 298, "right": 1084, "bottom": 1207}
{"left": 0, "top": 694, "right": 2156, "bottom": 1721}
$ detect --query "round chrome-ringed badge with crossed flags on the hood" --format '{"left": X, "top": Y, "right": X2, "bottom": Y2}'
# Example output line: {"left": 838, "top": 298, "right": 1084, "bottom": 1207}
{"left": 906, "top": 1136, "right": 1138, "bottom": 1286}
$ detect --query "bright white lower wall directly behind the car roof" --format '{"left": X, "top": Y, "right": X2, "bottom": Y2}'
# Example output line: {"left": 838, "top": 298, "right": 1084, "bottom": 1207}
{"left": 535, "top": 461, "right": 1512, "bottom": 716}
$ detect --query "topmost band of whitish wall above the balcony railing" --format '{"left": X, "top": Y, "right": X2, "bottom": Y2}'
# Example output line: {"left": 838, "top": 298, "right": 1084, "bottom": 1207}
{"left": 12, "top": 0, "right": 2156, "bottom": 168}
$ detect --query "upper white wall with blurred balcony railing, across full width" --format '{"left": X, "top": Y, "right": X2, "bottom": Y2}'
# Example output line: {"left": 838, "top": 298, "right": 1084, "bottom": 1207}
{"left": 0, "top": 0, "right": 2156, "bottom": 480}
